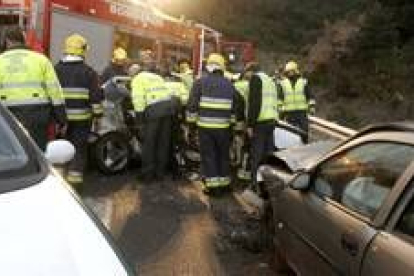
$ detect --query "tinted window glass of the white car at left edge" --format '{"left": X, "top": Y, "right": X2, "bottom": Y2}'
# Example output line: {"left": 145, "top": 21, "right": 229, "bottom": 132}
{"left": 0, "top": 114, "right": 29, "bottom": 174}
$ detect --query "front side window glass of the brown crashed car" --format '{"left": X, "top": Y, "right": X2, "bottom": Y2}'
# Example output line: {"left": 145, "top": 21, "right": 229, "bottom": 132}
{"left": 313, "top": 142, "right": 414, "bottom": 217}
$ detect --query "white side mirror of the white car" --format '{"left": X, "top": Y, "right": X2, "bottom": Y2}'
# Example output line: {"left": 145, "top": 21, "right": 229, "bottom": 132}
{"left": 45, "top": 140, "right": 76, "bottom": 165}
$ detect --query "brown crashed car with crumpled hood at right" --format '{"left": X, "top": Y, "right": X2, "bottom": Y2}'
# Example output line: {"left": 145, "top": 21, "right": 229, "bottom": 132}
{"left": 258, "top": 123, "right": 414, "bottom": 275}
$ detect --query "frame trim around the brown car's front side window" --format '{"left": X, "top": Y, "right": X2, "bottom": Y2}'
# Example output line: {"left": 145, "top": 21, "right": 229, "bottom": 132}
{"left": 308, "top": 132, "right": 414, "bottom": 228}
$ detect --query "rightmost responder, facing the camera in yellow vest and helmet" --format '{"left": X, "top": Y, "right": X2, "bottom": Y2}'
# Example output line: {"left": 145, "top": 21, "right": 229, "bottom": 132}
{"left": 279, "top": 61, "right": 315, "bottom": 142}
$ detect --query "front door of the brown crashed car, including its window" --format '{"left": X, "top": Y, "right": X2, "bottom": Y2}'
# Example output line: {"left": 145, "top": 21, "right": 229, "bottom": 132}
{"left": 278, "top": 140, "right": 414, "bottom": 275}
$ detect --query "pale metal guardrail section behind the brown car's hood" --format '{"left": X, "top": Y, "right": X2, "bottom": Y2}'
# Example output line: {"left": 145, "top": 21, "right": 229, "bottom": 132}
{"left": 309, "top": 116, "right": 357, "bottom": 140}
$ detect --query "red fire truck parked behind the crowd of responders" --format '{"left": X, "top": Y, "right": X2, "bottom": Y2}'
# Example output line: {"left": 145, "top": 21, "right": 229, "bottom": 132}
{"left": 0, "top": 0, "right": 221, "bottom": 72}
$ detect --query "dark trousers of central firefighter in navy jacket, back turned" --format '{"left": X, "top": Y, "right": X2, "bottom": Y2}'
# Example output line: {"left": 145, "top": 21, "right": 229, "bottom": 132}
{"left": 198, "top": 127, "right": 231, "bottom": 183}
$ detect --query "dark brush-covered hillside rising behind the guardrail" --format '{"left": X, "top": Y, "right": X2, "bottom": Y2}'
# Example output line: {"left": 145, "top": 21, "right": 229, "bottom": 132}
{"left": 158, "top": 0, "right": 414, "bottom": 127}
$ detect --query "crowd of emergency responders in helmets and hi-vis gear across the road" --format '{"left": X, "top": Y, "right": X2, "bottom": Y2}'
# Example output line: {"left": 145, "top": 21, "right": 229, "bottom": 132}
{"left": 0, "top": 26, "right": 315, "bottom": 193}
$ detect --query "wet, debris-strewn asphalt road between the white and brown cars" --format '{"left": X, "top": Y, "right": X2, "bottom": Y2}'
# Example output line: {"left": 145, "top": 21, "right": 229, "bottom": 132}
{"left": 82, "top": 170, "right": 275, "bottom": 276}
